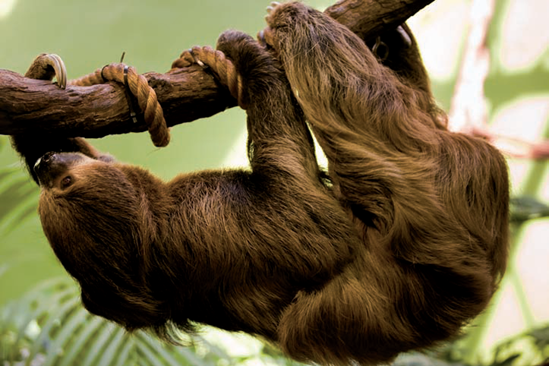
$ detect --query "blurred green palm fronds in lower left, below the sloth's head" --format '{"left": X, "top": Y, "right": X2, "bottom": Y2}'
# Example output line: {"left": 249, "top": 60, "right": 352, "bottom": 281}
{"left": 0, "top": 278, "right": 234, "bottom": 366}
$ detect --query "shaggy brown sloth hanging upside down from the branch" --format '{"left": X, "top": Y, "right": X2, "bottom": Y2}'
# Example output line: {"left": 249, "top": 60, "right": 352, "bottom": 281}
{"left": 9, "top": 3, "right": 509, "bottom": 365}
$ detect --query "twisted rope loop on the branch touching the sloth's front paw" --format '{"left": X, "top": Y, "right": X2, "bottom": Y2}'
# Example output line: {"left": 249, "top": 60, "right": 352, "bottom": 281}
{"left": 172, "top": 46, "right": 246, "bottom": 109}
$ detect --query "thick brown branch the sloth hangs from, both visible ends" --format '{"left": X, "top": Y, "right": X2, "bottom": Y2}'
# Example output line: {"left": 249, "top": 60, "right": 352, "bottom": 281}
{"left": 0, "top": 0, "right": 433, "bottom": 138}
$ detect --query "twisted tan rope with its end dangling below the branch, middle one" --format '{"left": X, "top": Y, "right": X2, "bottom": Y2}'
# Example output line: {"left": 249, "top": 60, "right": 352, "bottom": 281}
{"left": 69, "top": 63, "right": 170, "bottom": 147}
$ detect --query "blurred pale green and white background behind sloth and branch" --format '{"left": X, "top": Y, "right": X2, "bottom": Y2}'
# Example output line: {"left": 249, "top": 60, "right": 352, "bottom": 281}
{"left": 0, "top": 0, "right": 549, "bottom": 365}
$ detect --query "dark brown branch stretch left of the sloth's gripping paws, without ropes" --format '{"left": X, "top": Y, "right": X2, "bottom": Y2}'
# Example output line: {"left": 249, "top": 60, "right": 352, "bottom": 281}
{"left": 0, "top": 66, "right": 236, "bottom": 137}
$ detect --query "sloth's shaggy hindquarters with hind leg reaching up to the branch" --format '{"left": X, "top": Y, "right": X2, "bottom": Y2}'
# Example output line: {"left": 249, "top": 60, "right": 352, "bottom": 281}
{"left": 266, "top": 3, "right": 508, "bottom": 363}
